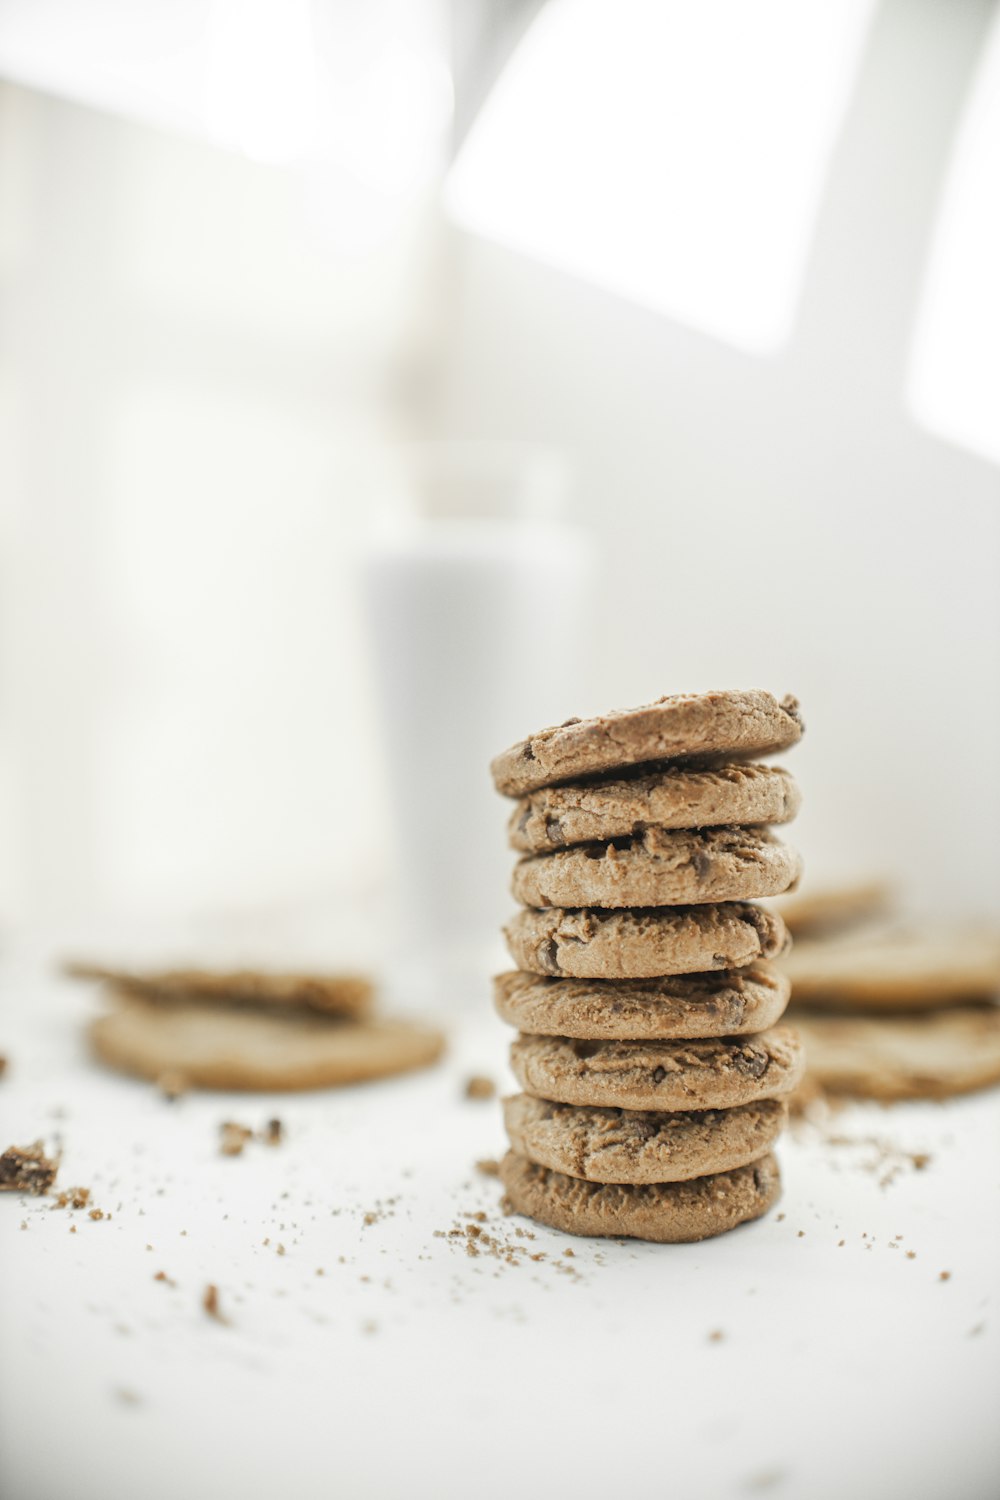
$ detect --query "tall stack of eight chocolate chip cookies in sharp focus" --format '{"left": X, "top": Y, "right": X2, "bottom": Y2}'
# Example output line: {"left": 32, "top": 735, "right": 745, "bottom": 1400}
{"left": 492, "top": 692, "right": 802, "bottom": 1242}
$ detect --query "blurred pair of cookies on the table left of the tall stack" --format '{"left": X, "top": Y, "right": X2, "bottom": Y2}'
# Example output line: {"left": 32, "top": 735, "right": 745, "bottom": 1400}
{"left": 67, "top": 963, "right": 444, "bottom": 1095}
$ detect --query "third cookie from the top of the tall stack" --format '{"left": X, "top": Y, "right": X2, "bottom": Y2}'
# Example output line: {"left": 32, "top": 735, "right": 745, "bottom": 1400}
{"left": 511, "top": 828, "right": 801, "bottom": 908}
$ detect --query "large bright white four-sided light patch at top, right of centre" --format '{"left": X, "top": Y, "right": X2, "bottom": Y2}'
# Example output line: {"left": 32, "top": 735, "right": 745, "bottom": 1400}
{"left": 447, "top": 0, "right": 873, "bottom": 353}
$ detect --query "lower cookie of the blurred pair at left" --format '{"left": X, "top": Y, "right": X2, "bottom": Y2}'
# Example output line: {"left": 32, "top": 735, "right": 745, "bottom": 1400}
{"left": 90, "top": 1001, "right": 444, "bottom": 1091}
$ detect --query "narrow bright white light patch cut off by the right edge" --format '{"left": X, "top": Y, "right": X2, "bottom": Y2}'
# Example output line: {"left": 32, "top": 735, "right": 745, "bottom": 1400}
{"left": 907, "top": 11, "right": 1000, "bottom": 464}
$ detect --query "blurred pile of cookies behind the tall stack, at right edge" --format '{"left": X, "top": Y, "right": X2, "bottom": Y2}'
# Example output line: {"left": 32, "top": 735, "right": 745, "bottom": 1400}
{"left": 775, "top": 882, "right": 1000, "bottom": 1107}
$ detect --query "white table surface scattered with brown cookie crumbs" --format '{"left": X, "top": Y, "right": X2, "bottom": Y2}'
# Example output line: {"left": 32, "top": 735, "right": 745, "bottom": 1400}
{"left": 0, "top": 936, "right": 1000, "bottom": 1500}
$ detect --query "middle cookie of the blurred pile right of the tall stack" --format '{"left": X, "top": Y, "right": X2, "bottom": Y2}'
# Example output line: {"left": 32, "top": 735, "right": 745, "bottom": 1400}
{"left": 783, "top": 929, "right": 1000, "bottom": 1011}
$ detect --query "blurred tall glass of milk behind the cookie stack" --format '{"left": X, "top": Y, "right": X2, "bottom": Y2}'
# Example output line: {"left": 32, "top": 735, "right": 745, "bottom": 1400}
{"left": 363, "top": 443, "right": 594, "bottom": 1005}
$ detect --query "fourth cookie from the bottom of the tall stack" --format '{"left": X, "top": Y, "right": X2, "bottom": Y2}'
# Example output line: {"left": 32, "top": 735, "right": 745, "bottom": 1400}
{"left": 493, "top": 963, "right": 792, "bottom": 1041}
